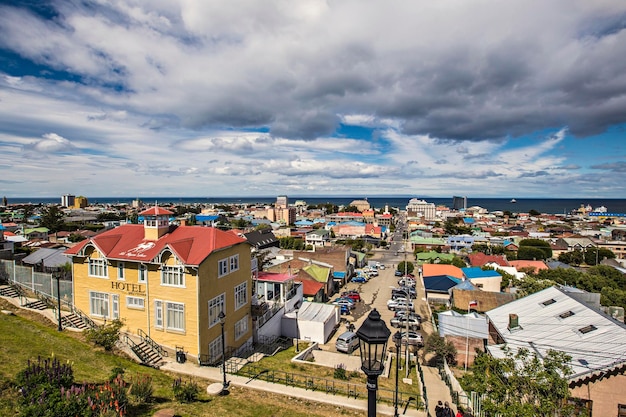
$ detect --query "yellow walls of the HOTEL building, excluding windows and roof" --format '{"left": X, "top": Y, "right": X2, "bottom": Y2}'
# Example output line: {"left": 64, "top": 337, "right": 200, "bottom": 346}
{"left": 73, "top": 239, "right": 252, "bottom": 355}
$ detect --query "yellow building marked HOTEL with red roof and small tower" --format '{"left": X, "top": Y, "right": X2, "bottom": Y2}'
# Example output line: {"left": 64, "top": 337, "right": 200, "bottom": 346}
{"left": 65, "top": 207, "right": 252, "bottom": 362}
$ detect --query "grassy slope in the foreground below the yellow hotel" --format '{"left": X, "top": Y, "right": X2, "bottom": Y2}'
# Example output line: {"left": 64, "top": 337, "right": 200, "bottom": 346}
{"left": 0, "top": 299, "right": 362, "bottom": 417}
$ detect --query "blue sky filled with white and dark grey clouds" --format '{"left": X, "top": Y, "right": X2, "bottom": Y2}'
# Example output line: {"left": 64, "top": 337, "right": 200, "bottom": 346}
{"left": 0, "top": 0, "right": 626, "bottom": 198}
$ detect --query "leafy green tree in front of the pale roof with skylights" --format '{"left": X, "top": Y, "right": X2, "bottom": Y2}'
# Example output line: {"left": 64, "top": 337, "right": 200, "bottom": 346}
{"left": 461, "top": 348, "right": 580, "bottom": 417}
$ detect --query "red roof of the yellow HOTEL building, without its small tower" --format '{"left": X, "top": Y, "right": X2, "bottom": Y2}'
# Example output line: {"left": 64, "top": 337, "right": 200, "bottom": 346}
{"left": 65, "top": 226, "right": 246, "bottom": 265}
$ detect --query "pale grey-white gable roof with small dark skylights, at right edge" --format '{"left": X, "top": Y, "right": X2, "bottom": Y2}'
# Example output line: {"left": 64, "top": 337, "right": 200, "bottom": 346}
{"left": 486, "top": 286, "right": 626, "bottom": 382}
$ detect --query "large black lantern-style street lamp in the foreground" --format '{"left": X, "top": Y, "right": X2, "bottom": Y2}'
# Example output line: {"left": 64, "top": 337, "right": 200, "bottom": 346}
{"left": 356, "top": 309, "right": 391, "bottom": 417}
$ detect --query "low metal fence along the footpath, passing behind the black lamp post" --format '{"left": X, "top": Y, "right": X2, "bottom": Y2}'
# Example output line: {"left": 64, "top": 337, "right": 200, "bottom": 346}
{"left": 226, "top": 362, "right": 424, "bottom": 410}
